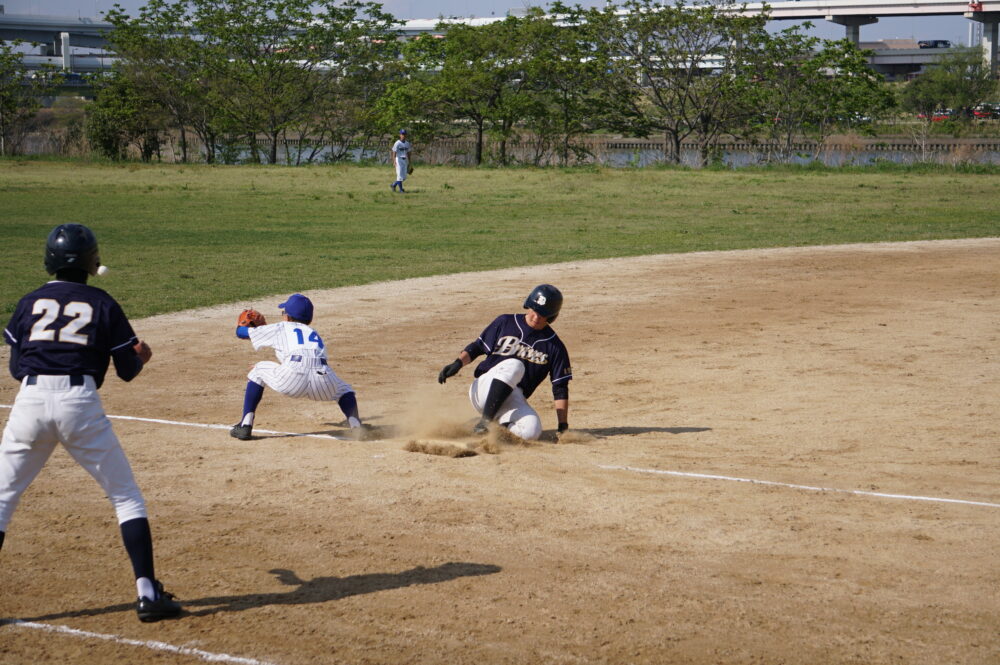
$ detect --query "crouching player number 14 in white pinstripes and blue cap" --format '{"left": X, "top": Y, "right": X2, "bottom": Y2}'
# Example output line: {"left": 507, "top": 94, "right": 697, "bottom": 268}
{"left": 229, "top": 293, "right": 364, "bottom": 441}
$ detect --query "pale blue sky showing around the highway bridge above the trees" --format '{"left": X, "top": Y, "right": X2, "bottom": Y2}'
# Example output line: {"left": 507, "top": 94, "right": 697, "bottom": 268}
{"left": 0, "top": 0, "right": 971, "bottom": 44}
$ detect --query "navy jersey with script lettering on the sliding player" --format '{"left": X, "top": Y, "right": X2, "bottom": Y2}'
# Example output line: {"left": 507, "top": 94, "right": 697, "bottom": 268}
{"left": 465, "top": 314, "right": 573, "bottom": 399}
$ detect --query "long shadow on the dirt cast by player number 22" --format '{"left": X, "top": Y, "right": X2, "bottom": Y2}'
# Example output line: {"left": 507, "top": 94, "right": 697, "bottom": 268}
{"left": 21, "top": 562, "right": 503, "bottom": 621}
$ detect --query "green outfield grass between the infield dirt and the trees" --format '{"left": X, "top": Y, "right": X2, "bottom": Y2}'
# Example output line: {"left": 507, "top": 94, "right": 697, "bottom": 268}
{"left": 0, "top": 159, "right": 1000, "bottom": 318}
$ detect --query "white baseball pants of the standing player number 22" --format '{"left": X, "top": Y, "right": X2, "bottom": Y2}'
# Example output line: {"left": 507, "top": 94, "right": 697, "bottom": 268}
{"left": 0, "top": 376, "right": 146, "bottom": 531}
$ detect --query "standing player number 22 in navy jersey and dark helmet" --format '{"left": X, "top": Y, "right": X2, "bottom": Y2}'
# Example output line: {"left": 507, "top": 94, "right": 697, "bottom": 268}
{"left": 0, "top": 224, "right": 181, "bottom": 622}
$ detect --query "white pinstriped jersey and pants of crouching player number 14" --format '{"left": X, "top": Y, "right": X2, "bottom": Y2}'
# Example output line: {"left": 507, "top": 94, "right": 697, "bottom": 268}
{"left": 247, "top": 321, "right": 352, "bottom": 401}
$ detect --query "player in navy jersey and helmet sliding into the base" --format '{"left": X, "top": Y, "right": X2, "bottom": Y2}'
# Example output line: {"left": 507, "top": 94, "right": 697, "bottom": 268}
{"left": 438, "top": 284, "right": 573, "bottom": 441}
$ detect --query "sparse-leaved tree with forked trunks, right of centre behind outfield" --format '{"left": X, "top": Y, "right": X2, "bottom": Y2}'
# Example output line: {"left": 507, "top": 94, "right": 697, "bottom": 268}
{"left": 586, "top": 0, "right": 767, "bottom": 163}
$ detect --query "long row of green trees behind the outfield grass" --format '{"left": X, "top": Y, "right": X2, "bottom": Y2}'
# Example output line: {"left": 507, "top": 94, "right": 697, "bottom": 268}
{"left": 0, "top": 0, "right": 996, "bottom": 165}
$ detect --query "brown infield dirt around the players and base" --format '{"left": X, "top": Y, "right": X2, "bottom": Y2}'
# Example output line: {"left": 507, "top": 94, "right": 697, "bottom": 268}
{"left": 0, "top": 239, "right": 1000, "bottom": 665}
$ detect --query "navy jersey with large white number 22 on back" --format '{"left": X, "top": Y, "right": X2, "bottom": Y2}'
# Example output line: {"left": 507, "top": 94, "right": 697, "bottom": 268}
{"left": 4, "top": 281, "right": 142, "bottom": 387}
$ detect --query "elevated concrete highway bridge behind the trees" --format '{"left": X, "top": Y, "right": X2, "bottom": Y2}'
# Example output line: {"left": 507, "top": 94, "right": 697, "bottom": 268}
{"left": 0, "top": 0, "right": 1000, "bottom": 75}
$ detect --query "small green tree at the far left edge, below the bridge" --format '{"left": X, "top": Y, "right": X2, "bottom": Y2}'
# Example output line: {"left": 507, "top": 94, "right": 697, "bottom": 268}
{"left": 0, "top": 41, "right": 62, "bottom": 155}
